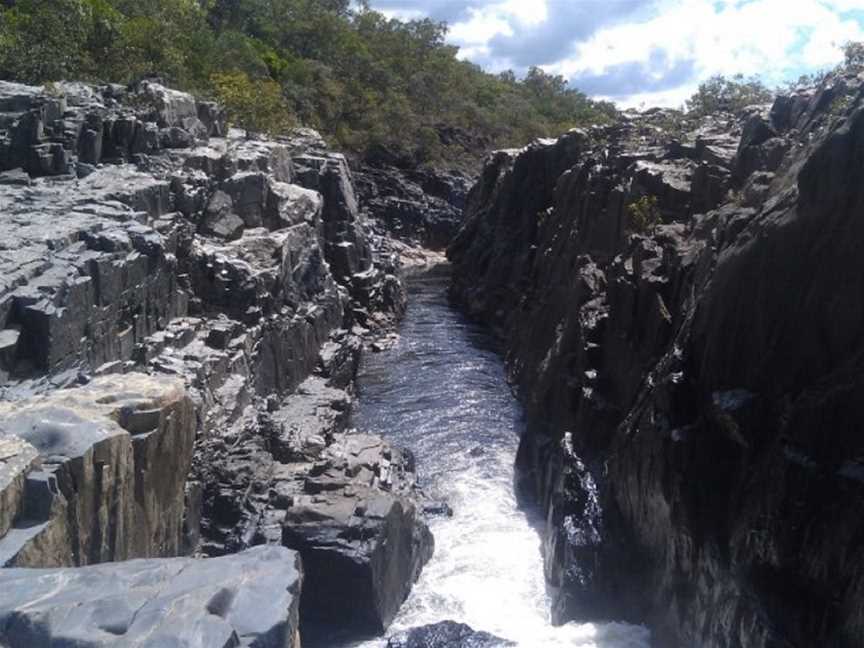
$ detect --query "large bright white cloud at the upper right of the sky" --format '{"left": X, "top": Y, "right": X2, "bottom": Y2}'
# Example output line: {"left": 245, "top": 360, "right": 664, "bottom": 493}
{"left": 546, "top": 0, "right": 864, "bottom": 106}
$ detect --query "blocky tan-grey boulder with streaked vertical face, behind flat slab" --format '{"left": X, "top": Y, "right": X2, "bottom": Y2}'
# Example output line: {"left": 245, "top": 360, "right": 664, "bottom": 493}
{"left": 0, "top": 374, "right": 196, "bottom": 566}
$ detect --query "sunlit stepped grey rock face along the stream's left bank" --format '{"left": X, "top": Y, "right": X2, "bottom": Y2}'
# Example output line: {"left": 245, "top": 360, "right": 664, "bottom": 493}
{"left": 0, "top": 81, "right": 432, "bottom": 646}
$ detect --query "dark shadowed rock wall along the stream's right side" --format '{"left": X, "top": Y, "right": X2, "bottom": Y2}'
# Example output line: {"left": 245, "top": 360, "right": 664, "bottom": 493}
{"left": 449, "top": 75, "right": 864, "bottom": 648}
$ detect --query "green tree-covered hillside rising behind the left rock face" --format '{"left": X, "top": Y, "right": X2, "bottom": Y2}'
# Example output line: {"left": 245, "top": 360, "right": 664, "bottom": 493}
{"left": 0, "top": 0, "right": 614, "bottom": 163}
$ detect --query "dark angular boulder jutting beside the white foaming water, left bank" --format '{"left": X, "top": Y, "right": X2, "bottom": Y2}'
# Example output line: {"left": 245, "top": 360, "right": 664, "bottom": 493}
{"left": 282, "top": 435, "right": 433, "bottom": 635}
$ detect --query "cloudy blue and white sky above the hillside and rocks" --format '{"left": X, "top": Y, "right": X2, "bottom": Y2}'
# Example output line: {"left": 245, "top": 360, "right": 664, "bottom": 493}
{"left": 370, "top": 0, "right": 864, "bottom": 107}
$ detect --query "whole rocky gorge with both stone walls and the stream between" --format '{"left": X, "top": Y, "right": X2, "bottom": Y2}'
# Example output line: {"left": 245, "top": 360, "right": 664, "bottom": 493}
{"left": 0, "top": 52, "right": 864, "bottom": 648}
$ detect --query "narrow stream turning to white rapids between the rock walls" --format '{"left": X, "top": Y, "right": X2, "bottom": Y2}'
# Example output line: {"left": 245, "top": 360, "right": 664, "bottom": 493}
{"left": 353, "top": 272, "right": 649, "bottom": 648}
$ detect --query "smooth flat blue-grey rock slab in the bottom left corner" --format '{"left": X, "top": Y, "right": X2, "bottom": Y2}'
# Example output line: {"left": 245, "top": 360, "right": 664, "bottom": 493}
{"left": 0, "top": 547, "right": 302, "bottom": 648}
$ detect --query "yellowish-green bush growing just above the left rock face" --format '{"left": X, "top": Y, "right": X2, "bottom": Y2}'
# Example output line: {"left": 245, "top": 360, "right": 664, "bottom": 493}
{"left": 212, "top": 72, "right": 294, "bottom": 137}
